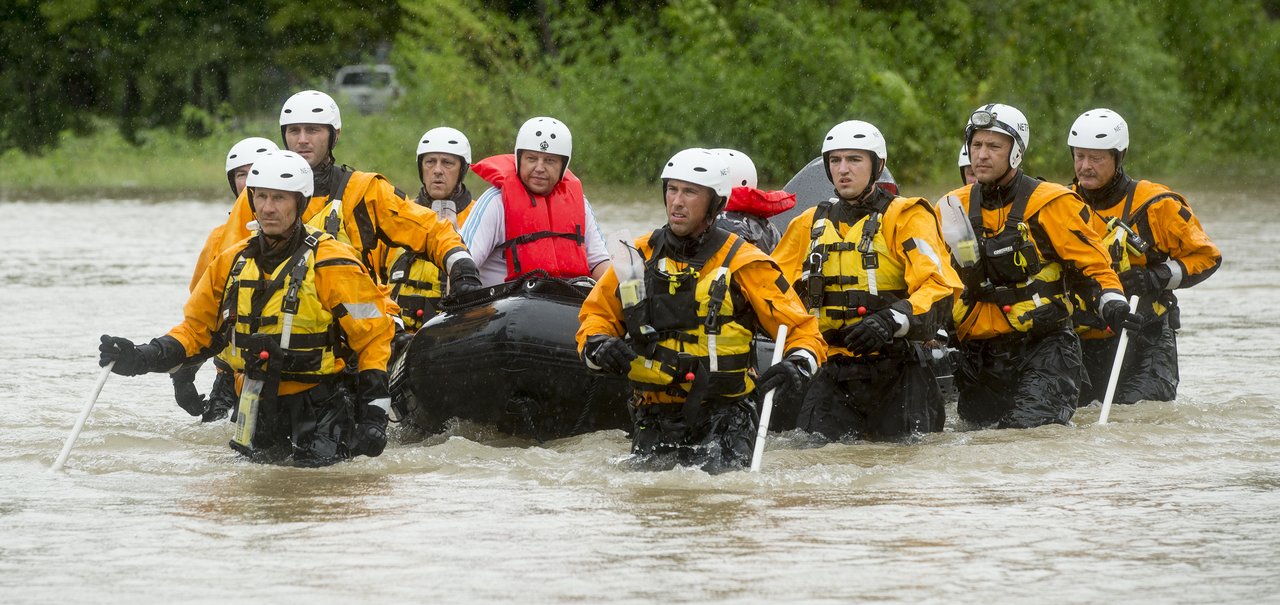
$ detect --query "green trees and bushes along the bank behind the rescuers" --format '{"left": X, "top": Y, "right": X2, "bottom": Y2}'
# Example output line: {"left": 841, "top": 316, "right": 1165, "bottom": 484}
{"left": 0, "top": 0, "right": 1280, "bottom": 197}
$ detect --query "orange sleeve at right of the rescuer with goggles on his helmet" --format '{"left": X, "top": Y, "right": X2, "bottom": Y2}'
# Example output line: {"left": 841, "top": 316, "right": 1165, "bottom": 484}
{"left": 1028, "top": 193, "right": 1128, "bottom": 310}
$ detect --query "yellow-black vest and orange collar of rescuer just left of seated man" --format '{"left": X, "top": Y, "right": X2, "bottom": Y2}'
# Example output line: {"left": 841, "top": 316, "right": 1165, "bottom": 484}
{"left": 388, "top": 183, "right": 472, "bottom": 334}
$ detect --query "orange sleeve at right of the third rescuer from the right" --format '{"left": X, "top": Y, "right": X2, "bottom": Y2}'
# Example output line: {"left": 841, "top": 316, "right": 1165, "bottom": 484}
{"left": 883, "top": 198, "right": 964, "bottom": 336}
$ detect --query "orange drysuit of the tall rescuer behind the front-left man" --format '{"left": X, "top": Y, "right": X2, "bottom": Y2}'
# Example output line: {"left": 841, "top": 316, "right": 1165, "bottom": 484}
{"left": 196, "top": 159, "right": 479, "bottom": 292}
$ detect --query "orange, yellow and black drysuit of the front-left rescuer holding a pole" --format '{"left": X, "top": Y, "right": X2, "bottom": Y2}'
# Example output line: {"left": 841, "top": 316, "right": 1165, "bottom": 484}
{"left": 165, "top": 224, "right": 396, "bottom": 466}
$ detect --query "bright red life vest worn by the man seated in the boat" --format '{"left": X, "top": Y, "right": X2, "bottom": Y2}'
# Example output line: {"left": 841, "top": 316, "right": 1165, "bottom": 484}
{"left": 471, "top": 153, "right": 591, "bottom": 280}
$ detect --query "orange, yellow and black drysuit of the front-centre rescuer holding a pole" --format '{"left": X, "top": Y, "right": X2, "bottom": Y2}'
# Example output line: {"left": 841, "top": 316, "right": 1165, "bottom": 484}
{"left": 577, "top": 226, "right": 826, "bottom": 472}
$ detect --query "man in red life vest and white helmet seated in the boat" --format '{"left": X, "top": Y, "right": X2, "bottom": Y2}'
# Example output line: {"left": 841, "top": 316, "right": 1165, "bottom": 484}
{"left": 462, "top": 118, "right": 609, "bottom": 287}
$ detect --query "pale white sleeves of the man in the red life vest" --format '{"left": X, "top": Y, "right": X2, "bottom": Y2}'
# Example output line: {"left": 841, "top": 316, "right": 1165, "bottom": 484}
{"left": 461, "top": 187, "right": 609, "bottom": 287}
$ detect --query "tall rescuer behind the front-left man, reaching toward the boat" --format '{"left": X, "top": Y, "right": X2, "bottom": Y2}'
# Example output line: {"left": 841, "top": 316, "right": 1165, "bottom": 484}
{"left": 197, "top": 91, "right": 480, "bottom": 292}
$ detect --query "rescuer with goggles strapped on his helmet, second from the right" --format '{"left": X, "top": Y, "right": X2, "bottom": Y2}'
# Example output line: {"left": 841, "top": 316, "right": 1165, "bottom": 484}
{"left": 938, "top": 104, "right": 1142, "bottom": 428}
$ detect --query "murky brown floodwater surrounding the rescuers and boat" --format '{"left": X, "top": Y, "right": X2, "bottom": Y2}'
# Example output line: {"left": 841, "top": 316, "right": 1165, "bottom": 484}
{"left": 0, "top": 187, "right": 1280, "bottom": 604}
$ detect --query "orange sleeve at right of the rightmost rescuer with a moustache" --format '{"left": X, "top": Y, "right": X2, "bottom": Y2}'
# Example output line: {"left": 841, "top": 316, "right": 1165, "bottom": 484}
{"left": 1147, "top": 197, "right": 1222, "bottom": 290}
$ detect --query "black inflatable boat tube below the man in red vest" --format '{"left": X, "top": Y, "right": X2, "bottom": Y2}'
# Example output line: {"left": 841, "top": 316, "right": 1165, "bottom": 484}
{"left": 393, "top": 271, "right": 631, "bottom": 441}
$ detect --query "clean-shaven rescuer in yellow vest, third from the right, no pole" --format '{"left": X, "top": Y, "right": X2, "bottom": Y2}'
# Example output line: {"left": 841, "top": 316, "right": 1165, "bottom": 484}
{"left": 773, "top": 120, "right": 961, "bottom": 440}
